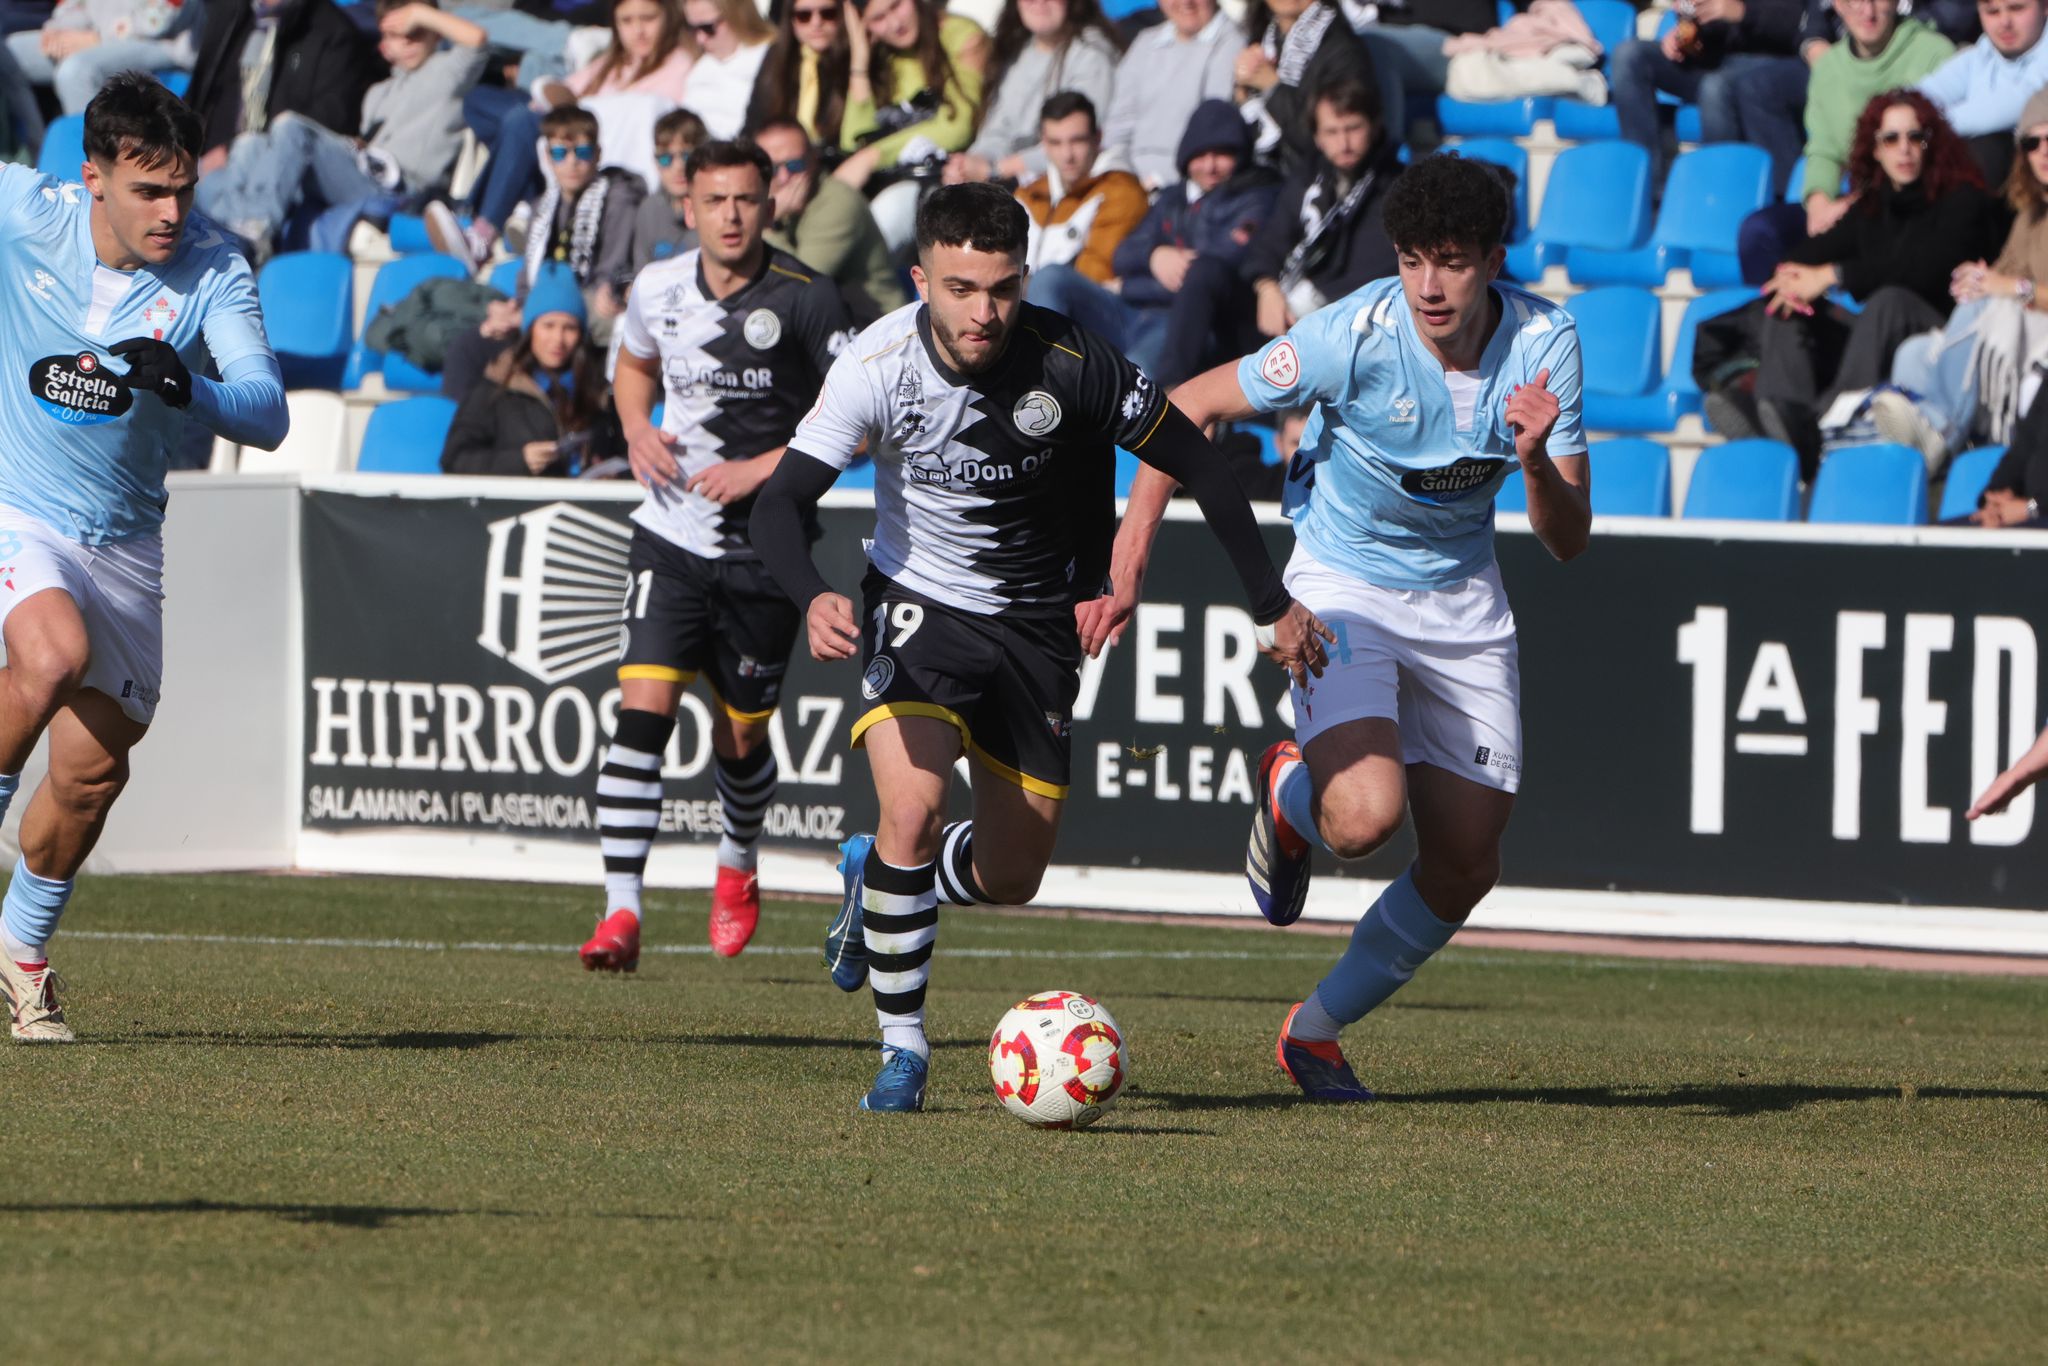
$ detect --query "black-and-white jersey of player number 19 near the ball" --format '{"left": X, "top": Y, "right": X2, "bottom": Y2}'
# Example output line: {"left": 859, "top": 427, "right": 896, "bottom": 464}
{"left": 791, "top": 303, "right": 1167, "bottom": 614}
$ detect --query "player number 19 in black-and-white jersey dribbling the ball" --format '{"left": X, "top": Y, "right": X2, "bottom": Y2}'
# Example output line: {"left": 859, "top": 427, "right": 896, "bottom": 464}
{"left": 752, "top": 184, "right": 1329, "bottom": 1110}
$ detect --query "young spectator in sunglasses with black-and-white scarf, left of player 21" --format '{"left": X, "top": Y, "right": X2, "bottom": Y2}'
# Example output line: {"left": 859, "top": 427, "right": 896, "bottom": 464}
{"left": 520, "top": 104, "right": 647, "bottom": 346}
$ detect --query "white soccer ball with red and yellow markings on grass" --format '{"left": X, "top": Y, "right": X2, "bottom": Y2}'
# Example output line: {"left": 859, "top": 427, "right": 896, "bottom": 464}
{"left": 989, "top": 991, "right": 1130, "bottom": 1128}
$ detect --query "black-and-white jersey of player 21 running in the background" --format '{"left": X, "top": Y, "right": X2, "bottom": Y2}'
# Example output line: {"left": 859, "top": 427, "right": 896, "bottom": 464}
{"left": 621, "top": 248, "right": 852, "bottom": 559}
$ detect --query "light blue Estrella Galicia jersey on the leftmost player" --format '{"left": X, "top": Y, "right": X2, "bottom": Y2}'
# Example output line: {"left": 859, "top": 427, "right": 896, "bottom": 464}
{"left": 0, "top": 166, "right": 285, "bottom": 545}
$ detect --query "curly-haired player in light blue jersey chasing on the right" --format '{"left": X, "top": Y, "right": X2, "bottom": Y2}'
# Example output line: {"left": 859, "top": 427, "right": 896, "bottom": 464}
{"left": 1102, "top": 156, "right": 1591, "bottom": 1100}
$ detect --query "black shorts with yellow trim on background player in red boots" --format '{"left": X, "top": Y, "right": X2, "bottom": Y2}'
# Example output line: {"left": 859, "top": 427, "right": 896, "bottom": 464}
{"left": 618, "top": 526, "right": 803, "bottom": 721}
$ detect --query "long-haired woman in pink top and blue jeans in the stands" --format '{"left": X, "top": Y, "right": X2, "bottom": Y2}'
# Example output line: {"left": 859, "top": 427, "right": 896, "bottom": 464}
{"left": 426, "top": 0, "right": 696, "bottom": 266}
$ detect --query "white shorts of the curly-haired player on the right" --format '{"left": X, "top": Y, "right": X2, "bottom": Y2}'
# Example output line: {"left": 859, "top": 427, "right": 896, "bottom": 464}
{"left": 1286, "top": 545, "right": 1522, "bottom": 793}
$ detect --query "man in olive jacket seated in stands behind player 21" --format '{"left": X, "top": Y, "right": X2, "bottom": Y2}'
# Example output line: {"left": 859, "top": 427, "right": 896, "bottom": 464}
{"left": 754, "top": 119, "right": 909, "bottom": 328}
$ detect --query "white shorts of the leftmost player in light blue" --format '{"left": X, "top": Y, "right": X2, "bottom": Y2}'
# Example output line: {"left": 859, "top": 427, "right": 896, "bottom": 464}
{"left": 0, "top": 504, "right": 164, "bottom": 725}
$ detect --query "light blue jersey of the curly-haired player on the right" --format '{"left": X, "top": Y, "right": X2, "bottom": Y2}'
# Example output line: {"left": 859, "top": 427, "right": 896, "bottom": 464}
{"left": 1237, "top": 276, "right": 1585, "bottom": 590}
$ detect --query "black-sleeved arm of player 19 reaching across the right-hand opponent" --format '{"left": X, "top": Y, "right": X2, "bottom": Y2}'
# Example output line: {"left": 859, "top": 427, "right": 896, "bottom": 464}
{"left": 1133, "top": 405, "right": 1337, "bottom": 682}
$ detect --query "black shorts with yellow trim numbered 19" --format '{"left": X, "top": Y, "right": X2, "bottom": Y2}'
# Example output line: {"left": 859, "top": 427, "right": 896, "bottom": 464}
{"left": 854, "top": 569, "right": 1081, "bottom": 799}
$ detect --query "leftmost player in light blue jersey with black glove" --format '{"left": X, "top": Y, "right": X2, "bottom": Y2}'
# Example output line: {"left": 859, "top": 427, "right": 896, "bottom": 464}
{"left": 0, "top": 72, "right": 285, "bottom": 1042}
